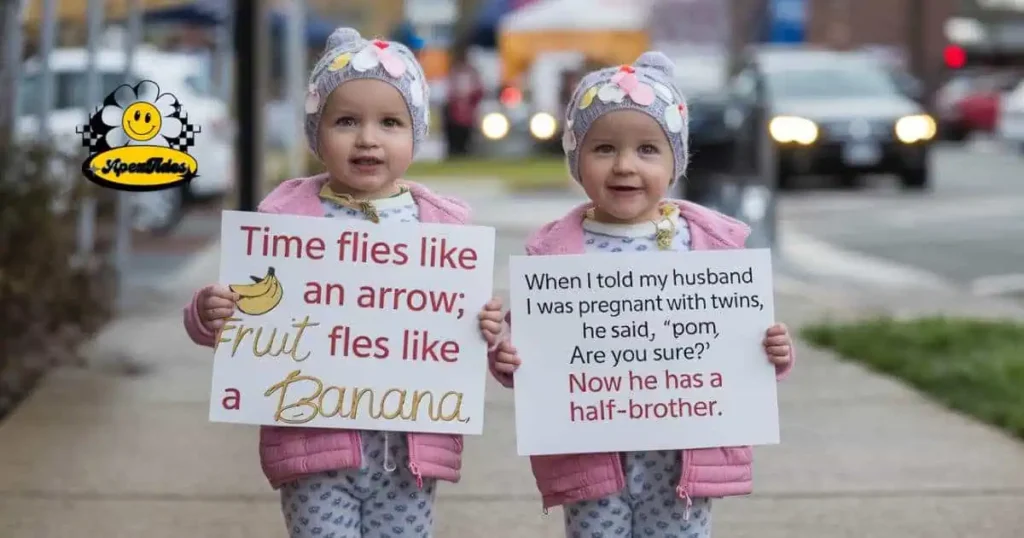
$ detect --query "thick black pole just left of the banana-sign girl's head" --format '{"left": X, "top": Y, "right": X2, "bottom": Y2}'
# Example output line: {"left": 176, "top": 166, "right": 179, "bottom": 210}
{"left": 234, "top": 0, "right": 267, "bottom": 211}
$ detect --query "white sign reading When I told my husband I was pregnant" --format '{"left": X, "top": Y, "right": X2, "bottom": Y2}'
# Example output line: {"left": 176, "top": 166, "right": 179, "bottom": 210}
{"left": 509, "top": 249, "right": 779, "bottom": 456}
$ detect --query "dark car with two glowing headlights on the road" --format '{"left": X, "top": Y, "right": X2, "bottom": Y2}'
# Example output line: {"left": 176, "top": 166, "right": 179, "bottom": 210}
{"left": 730, "top": 47, "right": 936, "bottom": 189}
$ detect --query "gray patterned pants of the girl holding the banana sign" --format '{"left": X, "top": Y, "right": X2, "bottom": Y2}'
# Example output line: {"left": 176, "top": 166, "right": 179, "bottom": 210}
{"left": 281, "top": 431, "right": 436, "bottom": 538}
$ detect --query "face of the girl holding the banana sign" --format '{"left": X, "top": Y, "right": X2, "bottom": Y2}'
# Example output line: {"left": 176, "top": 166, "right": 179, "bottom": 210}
{"left": 317, "top": 79, "right": 413, "bottom": 198}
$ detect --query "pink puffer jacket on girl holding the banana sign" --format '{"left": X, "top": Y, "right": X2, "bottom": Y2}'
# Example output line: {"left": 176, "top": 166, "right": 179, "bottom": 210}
{"left": 183, "top": 174, "right": 470, "bottom": 489}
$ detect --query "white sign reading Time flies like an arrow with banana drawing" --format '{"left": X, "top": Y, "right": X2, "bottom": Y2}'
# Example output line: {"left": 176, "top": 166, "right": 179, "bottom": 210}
{"left": 210, "top": 211, "right": 495, "bottom": 434}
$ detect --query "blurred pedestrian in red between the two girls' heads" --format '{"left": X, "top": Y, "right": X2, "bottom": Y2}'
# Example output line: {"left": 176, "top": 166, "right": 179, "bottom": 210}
{"left": 442, "top": 46, "right": 483, "bottom": 157}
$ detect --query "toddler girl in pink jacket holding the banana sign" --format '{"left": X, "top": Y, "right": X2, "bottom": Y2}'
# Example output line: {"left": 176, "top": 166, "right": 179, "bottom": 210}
{"left": 184, "top": 29, "right": 501, "bottom": 538}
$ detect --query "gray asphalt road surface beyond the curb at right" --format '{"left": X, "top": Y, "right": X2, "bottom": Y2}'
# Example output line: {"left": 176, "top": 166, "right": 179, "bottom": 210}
{"left": 780, "top": 141, "right": 1024, "bottom": 294}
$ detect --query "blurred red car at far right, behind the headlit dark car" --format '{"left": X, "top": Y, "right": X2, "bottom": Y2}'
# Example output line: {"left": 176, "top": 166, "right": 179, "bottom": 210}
{"left": 934, "top": 72, "right": 1021, "bottom": 141}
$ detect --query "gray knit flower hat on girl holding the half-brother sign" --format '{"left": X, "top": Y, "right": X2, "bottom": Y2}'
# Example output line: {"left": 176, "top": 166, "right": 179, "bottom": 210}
{"left": 562, "top": 51, "right": 689, "bottom": 181}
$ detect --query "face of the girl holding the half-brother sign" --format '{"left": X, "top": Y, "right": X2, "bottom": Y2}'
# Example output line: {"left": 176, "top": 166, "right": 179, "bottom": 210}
{"left": 579, "top": 110, "right": 674, "bottom": 223}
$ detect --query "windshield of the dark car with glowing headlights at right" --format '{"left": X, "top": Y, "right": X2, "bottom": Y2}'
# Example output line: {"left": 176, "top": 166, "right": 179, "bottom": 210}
{"left": 768, "top": 66, "right": 899, "bottom": 99}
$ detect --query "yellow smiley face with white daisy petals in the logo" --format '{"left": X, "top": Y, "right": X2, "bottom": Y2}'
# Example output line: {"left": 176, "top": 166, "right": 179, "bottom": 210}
{"left": 100, "top": 80, "right": 182, "bottom": 148}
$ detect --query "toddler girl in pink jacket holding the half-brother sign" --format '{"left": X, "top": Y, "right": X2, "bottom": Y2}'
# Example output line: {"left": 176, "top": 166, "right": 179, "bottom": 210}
{"left": 480, "top": 52, "right": 793, "bottom": 538}
